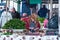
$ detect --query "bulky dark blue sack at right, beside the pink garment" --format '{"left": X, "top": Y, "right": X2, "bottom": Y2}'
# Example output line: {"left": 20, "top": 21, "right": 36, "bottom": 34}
{"left": 48, "top": 15, "right": 58, "bottom": 29}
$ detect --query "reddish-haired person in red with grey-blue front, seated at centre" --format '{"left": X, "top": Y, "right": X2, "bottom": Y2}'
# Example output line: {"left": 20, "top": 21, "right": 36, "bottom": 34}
{"left": 29, "top": 13, "right": 40, "bottom": 33}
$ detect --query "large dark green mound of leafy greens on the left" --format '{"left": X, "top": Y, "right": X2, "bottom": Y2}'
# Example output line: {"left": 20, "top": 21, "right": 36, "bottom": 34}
{"left": 2, "top": 19, "right": 25, "bottom": 29}
